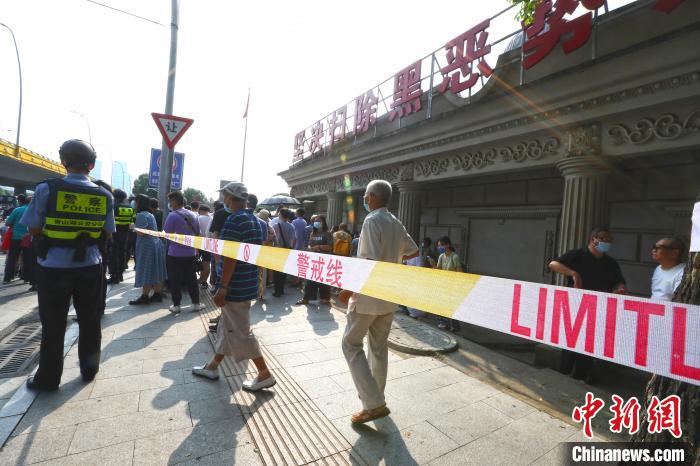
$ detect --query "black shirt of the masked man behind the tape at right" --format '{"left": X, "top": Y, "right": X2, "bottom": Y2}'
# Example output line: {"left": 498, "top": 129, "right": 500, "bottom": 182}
{"left": 554, "top": 248, "right": 625, "bottom": 293}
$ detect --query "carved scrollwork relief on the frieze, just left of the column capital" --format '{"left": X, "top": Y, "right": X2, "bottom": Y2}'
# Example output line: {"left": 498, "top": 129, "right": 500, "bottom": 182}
{"left": 415, "top": 138, "right": 561, "bottom": 178}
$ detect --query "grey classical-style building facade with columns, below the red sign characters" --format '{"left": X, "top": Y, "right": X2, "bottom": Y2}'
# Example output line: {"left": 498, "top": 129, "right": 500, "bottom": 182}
{"left": 280, "top": 0, "right": 700, "bottom": 295}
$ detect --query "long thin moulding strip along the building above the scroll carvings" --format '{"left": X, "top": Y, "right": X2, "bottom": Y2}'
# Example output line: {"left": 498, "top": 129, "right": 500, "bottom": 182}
{"left": 290, "top": 71, "right": 700, "bottom": 170}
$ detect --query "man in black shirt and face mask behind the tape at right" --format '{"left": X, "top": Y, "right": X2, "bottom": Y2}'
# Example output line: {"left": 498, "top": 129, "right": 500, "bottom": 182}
{"left": 549, "top": 227, "right": 627, "bottom": 383}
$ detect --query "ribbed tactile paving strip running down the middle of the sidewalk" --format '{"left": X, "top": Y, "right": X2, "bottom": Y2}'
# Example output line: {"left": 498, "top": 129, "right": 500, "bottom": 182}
{"left": 200, "top": 293, "right": 365, "bottom": 466}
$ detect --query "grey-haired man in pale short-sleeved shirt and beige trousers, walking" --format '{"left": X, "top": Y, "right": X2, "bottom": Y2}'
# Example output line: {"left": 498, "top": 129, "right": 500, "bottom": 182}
{"left": 340, "top": 180, "right": 418, "bottom": 424}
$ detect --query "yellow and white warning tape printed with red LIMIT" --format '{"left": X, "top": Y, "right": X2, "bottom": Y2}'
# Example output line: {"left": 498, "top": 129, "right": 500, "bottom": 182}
{"left": 137, "top": 230, "right": 700, "bottom": 385}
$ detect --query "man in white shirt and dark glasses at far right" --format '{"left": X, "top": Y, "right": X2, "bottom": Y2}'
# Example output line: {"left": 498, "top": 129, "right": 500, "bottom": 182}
{"left": 651, "top": 237, "right": 685, "bottom": 301}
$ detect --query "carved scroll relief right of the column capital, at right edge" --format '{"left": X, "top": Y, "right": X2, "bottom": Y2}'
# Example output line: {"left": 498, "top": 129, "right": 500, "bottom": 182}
{"left": 608, "top": 109, "right": 700, "bottom": 146}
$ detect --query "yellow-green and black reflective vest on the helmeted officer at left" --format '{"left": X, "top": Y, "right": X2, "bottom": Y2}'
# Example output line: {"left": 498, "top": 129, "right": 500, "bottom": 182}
{"left": 43, "top": 179, "right": 109, "bottom": 248}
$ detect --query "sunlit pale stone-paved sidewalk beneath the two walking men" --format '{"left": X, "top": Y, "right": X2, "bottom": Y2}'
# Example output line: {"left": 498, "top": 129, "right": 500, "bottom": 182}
{"left": 0, "top": 274, "right": 597, "bottom": 465}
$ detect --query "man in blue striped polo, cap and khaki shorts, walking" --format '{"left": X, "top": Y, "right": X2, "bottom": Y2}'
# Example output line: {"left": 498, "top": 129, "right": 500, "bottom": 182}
{"left": 192, "top": 181, "right": 276, "bottom": 391}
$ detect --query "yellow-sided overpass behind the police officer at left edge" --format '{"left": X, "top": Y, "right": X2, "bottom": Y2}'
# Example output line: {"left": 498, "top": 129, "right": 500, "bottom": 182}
{"left": 0, "top": 139, "right": 66, "bottom": 194}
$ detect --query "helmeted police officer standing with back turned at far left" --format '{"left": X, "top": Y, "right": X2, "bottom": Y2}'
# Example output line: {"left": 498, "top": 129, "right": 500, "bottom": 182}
{"left": 21, "top": 139, "right": 115, "bottom": 391}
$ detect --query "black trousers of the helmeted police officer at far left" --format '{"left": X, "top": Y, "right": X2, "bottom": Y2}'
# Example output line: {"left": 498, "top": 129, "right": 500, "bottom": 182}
{"left": 34, "top": 265, "right": 103, "bottom": 387}
